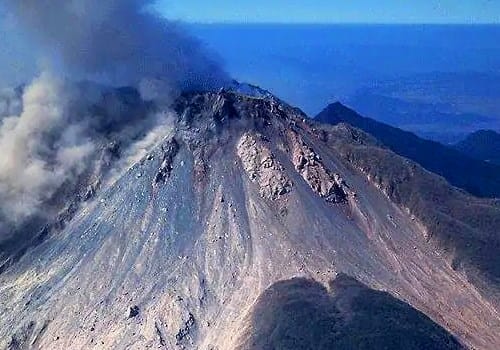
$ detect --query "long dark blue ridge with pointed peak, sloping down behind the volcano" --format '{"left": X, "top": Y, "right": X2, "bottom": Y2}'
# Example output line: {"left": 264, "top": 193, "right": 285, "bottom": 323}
{"left": 316, "top": 103, "right": 500, "bottom": 197}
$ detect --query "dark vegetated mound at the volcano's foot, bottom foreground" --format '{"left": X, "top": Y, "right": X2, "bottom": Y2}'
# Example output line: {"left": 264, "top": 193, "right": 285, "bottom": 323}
{"left": 240, "top": 275, "right": 462, "bottom": 350}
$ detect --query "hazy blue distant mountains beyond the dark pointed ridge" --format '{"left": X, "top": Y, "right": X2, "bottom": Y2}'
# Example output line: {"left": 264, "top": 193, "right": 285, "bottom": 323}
{"left": 343, "top": 72, "right": 500, "bottom": 144}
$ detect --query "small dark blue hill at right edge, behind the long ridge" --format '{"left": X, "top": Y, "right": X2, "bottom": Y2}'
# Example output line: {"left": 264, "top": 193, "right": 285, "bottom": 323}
{"left": 454, "top": 130, "right": 500, "bottom": 164}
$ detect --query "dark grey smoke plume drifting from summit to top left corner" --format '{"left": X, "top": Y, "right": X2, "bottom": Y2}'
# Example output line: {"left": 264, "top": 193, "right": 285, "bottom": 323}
{"left": 3, "top": 0, "right": 228, "bottom": 90}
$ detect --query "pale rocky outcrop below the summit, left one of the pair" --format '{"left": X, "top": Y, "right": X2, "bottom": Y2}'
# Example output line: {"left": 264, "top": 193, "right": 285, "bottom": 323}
{"left": 237, "top": 133, "right": 292, "bottom": 200}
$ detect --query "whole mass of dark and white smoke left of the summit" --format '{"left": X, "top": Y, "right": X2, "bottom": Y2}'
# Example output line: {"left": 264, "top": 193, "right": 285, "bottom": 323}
{"left": 0, "top": 0, "right": 229, "bottom": 235}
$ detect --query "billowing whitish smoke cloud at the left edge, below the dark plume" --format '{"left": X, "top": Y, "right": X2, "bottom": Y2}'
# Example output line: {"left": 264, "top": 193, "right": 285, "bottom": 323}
{"left": 0, "top": 74, "right": 94, "bottom": 222}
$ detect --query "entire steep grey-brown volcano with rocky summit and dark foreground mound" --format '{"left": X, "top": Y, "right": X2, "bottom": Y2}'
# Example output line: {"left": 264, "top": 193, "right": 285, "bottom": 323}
{"left": 0, "top": 90, "right": 500, "bottom": 350}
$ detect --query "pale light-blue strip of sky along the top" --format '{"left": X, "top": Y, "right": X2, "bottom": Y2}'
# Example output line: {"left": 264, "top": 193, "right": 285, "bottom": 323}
{"left": 157, "top": 0, "right": 500, "bottom": 23}
